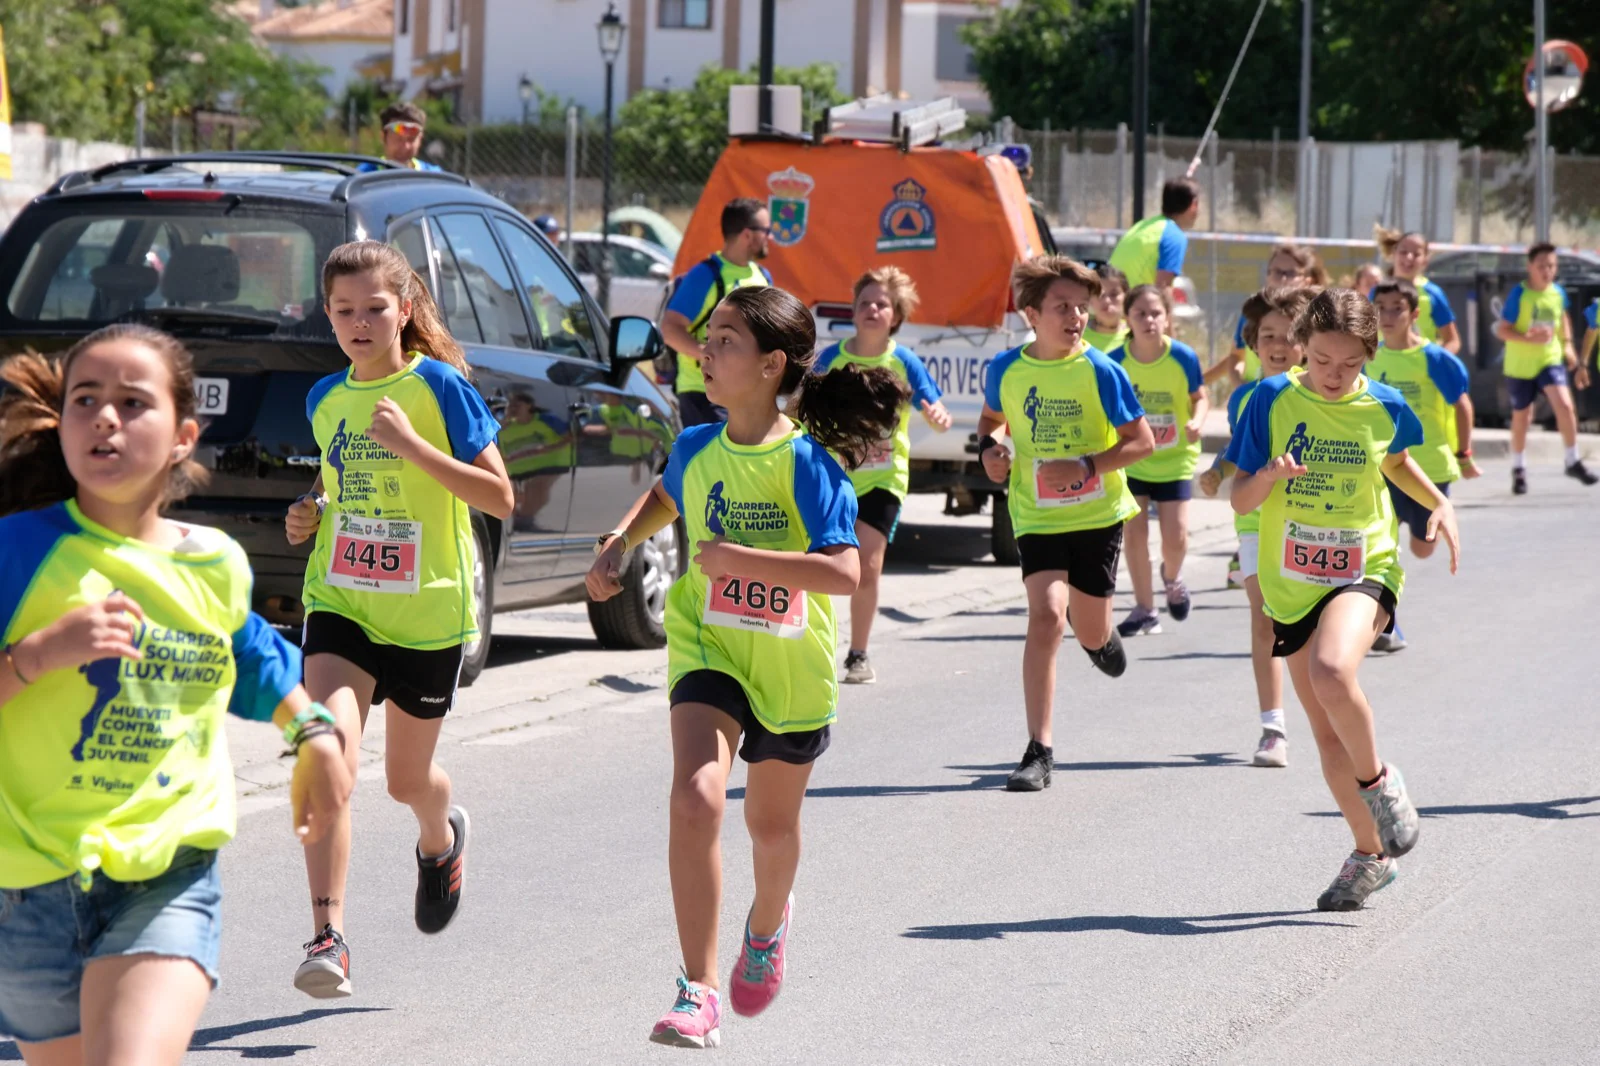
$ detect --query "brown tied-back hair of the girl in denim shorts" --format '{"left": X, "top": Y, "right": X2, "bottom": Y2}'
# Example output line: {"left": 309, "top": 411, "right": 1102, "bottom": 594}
{"left": 0, "top": 323, "right": 206, "bottom": 514}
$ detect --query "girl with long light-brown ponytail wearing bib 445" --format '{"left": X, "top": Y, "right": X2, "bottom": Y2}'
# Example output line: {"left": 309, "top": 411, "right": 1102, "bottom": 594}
{"left": 285, "top": 240, "right": 514, "bottom": 999}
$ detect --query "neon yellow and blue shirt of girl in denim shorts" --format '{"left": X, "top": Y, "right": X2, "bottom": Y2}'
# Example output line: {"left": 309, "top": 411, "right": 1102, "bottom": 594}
{"left": 0, "top": 501, "right": 301, "bottom": 888}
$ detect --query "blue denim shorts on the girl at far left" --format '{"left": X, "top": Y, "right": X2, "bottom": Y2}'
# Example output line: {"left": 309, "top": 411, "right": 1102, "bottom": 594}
{"left": 0, "top": 848, "right": 222, "bottom": 1044}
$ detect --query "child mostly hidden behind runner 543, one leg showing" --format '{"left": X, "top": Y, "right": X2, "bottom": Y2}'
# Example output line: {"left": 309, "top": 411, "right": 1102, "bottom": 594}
{"left": 1200, "top": 281, "right": 1318, "bottom": 767}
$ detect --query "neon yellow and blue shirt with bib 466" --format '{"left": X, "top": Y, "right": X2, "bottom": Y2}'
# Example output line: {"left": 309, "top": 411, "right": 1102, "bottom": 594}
{"left": 661, "top": 424, "right": 858, "bottom": 733}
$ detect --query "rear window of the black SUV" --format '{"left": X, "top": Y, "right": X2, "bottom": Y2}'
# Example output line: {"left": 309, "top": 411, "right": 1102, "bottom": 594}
{"left": 0, "top": 203, "right": 341, "bottom": 339}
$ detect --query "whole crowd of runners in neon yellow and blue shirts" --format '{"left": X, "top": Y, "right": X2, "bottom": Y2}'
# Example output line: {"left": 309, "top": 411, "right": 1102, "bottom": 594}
{"left": 0, "top": 202, "right": 1597, "bottom": 1066}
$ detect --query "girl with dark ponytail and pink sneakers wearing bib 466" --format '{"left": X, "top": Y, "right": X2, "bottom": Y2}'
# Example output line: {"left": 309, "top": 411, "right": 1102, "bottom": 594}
{"left": 587, "top": 281, "right": 906, "bottom": 1047}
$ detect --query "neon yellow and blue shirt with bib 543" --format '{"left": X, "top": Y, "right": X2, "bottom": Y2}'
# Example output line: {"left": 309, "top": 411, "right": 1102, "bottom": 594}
{"left": 1224, "top": 367, "right": 1422, "bottom": 623}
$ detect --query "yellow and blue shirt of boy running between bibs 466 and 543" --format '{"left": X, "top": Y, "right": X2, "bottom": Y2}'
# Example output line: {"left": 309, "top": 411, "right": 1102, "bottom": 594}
{"left": 984, "top": 344, "right": 1144, "bottom": 536}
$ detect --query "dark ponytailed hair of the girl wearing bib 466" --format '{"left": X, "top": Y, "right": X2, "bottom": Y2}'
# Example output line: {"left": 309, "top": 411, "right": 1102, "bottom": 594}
{"left": 723, "top": 285, "right": 909, "bottom": 469}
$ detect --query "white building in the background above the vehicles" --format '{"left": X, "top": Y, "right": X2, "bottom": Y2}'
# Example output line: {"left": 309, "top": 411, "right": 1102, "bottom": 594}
{"left": 388, "top": 0, "right": 1016, "bottom": 122}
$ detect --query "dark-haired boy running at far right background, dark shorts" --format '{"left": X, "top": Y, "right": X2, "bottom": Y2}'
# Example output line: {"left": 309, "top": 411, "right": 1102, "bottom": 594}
{"left": 1494, "top": 242, "right": 1600, "bottom": 496}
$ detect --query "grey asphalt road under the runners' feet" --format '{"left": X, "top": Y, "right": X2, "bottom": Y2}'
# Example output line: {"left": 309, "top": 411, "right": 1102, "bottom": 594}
{"left": 0, "top": 463, "right": 1600, "bottom": 1066}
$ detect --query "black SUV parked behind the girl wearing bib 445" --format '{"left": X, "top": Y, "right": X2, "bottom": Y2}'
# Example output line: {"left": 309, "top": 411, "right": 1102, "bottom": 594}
{"left": 0, "top": 152, "right": 683, "bottom": 683}
